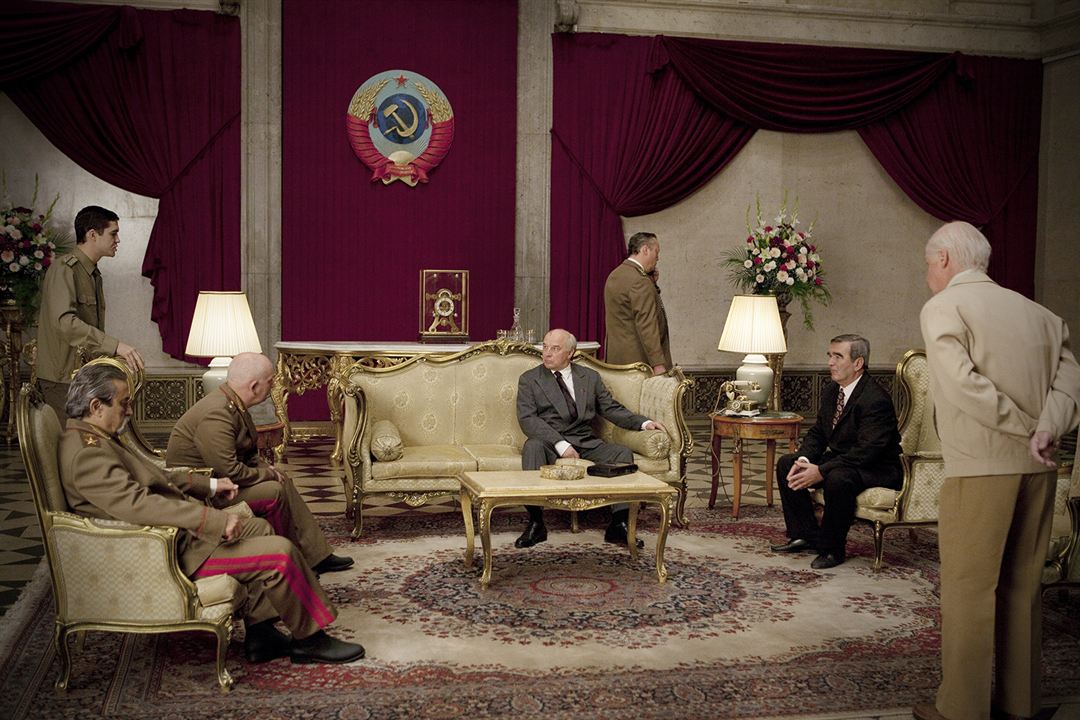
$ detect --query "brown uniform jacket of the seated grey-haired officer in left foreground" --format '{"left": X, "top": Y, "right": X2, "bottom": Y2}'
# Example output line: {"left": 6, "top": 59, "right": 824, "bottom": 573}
{"left": 58, "top": 420, "right": 229, "bottom": 575}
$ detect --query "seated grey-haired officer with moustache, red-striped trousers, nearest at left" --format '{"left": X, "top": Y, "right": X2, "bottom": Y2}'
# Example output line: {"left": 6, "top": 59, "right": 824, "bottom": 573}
{"left": 58, "top": 365, "right": 364, "bottom": 663}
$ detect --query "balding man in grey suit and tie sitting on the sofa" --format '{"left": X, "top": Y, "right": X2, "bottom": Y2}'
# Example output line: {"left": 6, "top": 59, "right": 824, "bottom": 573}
{"left": 514, "top": 329, "right": 664, "bottom": 547}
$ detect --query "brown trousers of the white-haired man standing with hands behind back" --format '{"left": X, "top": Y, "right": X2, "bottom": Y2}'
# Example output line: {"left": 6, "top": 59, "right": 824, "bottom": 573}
{"left": 936, "top": 472, "right": 1055, "bottom": 720}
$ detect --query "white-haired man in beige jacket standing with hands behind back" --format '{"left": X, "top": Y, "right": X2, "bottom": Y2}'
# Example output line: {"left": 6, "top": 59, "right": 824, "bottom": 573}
{"left": 914, "top": 222, "right": 1080, "bottom": 720}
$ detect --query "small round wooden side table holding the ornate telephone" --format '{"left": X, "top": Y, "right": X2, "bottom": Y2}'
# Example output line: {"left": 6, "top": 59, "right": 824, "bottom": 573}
{"left": 708, "top": 412, "right": 802, "bottom": 518}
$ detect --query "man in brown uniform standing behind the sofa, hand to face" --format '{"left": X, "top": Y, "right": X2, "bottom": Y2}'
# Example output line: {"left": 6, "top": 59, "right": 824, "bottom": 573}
{"left": 604, "top": 232, "right": 672, "bottom": 375}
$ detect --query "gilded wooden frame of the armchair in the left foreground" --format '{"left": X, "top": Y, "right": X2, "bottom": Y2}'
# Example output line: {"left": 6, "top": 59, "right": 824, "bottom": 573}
{"left": 15, "top": 383, "right": 239, "bottom": 692}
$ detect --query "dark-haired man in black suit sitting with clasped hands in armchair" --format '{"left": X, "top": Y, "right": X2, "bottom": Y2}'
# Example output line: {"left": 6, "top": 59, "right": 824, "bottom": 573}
{"left": 772, "top": 335, "right": 904, "bottom": 570}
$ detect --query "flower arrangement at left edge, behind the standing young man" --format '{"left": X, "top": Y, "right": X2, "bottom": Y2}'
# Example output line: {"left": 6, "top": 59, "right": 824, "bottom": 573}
{"left": 0, "top": 178, "right": 69, "bottom": 324}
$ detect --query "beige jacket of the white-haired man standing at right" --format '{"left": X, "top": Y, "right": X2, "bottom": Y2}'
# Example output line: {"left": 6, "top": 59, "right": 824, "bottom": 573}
{"left": 919, "top": 271, "right": 1080, "bottom": 477}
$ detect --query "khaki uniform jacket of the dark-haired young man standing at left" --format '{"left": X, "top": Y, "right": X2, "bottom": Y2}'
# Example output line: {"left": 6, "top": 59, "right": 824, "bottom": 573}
{"left": 38, "top": 247, "right": 119, "bottom": 383}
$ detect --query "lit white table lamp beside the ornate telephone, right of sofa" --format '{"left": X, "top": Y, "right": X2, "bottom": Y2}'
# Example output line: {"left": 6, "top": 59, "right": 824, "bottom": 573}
{"left": 716, "top": 295, "right": 787, "bottom": 407}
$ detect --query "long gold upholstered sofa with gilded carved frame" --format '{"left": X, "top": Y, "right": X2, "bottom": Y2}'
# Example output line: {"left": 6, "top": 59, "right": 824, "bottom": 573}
{"left": 337, "top": 340, "right": 693, "bottom": 536}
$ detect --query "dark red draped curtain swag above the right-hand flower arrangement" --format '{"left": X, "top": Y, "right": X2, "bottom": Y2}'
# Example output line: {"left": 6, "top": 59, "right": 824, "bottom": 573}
{"left": 551, "top": 33, "right": 1041, "bottom": 345}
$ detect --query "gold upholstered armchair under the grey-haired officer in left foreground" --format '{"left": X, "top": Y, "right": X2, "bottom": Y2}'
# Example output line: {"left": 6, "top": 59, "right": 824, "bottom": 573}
{"left": 16, "top": 384, "right": 246, "bottom": 692}
